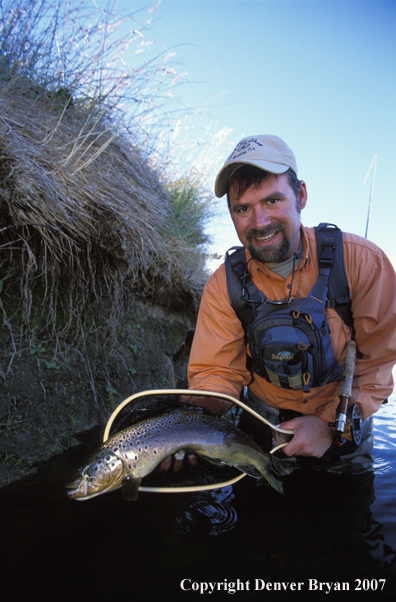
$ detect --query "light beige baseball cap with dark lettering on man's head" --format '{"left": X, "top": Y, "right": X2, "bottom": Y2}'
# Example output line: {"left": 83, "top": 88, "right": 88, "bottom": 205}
{"left": 215, "top": 135, "right": 297, "bottom": 198}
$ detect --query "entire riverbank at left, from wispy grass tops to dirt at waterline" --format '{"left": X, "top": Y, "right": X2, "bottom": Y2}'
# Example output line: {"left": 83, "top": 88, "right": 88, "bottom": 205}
{"left": 0, "top": 0, "right": 209, "bottom": 486}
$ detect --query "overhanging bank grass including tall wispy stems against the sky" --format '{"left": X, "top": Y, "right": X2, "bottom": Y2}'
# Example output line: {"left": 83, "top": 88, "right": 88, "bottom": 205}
{"left": 0, "top": 0, "right": 208, "bottom": 346}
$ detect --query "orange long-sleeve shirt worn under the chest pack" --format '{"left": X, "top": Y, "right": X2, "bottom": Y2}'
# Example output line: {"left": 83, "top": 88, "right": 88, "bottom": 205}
{"left": 188, "top": 227, "right": 396, "bottom": 422}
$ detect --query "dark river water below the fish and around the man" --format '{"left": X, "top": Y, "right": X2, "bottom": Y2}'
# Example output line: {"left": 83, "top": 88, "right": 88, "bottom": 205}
{"left": 0, "top": 382, "right": 396, "bottom": 602}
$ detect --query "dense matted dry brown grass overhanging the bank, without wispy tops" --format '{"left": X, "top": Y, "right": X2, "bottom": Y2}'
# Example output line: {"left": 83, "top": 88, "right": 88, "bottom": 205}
{"left": 0, "top": 3, "right": 206, "bottom": 342}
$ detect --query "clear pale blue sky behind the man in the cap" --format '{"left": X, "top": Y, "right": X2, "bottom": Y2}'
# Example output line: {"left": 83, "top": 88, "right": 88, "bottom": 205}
{"left": 98, "top": 0, "right": 396, "bottom": 262}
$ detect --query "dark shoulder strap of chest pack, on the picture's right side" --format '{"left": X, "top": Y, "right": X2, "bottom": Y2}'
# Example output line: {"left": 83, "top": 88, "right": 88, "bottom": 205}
{"left": 315, "top": 223, "right": 353, "bottom": 328}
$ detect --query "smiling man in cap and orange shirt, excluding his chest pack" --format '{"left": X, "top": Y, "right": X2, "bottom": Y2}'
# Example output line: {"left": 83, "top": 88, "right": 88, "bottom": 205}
{"left": 186, "top": 135, "right": 396, "bottom": 472}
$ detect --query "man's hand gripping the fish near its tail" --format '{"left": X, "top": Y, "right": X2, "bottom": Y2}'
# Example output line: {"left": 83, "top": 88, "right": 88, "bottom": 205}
{"left": 280, "top": 414, "right": 335, "bottom": 458}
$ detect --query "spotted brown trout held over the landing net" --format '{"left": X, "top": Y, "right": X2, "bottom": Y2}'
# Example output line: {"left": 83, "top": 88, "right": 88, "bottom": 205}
{"left": 68, "top": 411, "right": 283, "bottom": 500}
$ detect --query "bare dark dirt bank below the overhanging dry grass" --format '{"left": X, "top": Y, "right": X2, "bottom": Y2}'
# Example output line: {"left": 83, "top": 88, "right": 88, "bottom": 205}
{"left": 0, "top": 301, "right": 193, "bottom": 487}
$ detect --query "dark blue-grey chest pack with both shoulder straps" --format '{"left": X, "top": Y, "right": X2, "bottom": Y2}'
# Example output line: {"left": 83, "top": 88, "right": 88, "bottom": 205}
{"left": 225, "top": 224, "right": 353, "bottom": 392}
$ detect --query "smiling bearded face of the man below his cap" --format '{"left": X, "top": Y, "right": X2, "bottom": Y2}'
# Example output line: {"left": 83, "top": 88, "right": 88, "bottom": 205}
{"left": 228, "top": 174, "right": 307, "bottom": 263}
